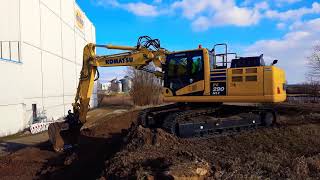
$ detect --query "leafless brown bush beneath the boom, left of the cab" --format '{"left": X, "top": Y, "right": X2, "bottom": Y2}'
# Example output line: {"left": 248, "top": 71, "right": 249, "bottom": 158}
{"left": 127, "top": 68, "right": 162, "bottom": 106}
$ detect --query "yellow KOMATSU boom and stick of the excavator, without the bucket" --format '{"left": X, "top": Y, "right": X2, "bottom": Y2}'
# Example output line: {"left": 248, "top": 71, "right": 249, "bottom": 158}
{"left": 73, "top": 44, "right": 167, "bottom": 123}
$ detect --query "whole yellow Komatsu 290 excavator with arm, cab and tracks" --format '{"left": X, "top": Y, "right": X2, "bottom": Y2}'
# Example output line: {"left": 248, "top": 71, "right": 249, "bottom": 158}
{"left": 48, "top": 36, "right": 286, "bottom": 151}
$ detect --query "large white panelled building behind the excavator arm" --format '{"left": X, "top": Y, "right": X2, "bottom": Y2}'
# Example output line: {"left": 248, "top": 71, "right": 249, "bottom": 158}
{"left": 0, "top": 0, "right": 96, "bottom": 136}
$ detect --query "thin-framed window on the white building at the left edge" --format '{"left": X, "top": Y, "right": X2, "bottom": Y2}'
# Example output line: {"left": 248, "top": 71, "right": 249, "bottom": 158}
{"left": 0, "top": 41, "right": 21, "bottom": 63}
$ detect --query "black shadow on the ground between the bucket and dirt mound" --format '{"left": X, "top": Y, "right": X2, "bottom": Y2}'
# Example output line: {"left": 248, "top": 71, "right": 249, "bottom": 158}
{"left": 37, "top": 133, "right": 122, "bottom": 179}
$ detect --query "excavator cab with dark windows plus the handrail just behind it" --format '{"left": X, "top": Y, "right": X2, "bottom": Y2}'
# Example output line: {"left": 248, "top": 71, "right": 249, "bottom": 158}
{"left": 162, "top": 43, "right": 237, "bottom": 98}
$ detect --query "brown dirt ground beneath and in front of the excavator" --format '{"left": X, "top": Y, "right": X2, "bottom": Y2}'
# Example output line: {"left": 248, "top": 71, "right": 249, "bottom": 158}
{"left": 0, "top": 104, "right": 320, "bottom": 179}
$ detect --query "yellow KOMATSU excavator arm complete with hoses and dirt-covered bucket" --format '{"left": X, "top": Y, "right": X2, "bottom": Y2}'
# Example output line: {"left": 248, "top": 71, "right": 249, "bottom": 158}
{"left": 48, "top": 36, "right": 169, "bottom": 151}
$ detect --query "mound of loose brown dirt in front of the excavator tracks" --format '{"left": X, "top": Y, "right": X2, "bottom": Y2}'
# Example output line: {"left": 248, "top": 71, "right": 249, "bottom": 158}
{"left": 104, "top": 125, "right": 210, "bottom": 179}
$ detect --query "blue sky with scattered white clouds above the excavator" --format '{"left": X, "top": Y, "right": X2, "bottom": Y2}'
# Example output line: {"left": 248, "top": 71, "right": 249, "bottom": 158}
{"left": 77, "top": 0, "right": 320, "bottom": 83}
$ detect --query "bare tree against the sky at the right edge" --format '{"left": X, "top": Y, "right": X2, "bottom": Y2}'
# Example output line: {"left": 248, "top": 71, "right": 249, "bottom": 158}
{"left": 307, "top": 44, "right": 320, "bottom": 82}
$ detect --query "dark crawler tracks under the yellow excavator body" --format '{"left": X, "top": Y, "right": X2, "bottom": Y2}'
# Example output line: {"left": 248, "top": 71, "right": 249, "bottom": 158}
{"left": 139, "top": 104, "right": 276, "bottom": 138}
